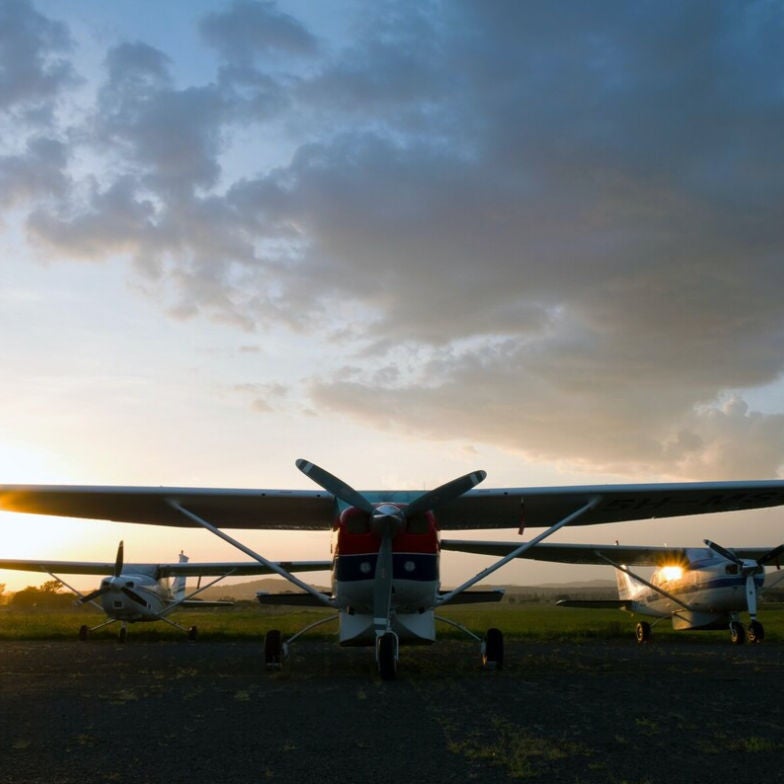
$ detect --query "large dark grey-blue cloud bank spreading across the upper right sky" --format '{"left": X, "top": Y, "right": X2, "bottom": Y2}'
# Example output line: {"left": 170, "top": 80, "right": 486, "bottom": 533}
{"left": 0, "top": 1, "right": 784, "bottom": 476}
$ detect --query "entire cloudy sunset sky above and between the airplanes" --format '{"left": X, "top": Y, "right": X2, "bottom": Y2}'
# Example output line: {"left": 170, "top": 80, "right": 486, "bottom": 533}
{"left": 0, "top": 0, "right": 784, "bottom": 589}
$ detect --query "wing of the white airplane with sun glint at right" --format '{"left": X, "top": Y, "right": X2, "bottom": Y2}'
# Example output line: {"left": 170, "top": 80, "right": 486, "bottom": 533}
{"left": 441, "top": 539, "right": 770, "bottom": 566}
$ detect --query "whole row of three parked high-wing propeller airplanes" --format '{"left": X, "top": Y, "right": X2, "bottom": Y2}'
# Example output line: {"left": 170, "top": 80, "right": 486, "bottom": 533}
{"left": 0, "top": 460, "right": 784, "bottom": 680}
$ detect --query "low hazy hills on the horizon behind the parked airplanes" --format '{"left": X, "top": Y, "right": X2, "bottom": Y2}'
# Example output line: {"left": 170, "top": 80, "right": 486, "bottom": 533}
{"left": 199, "top": 577, "right": 617, "bottom": 602}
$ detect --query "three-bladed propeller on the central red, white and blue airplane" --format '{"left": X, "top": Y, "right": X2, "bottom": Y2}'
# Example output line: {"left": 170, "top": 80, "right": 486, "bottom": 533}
{"left": 296, "top": 459, "right": 487, "bottom": 634}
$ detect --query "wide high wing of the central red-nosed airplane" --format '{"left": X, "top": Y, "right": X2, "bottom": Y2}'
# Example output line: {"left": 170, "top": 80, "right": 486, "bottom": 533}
{"left": 0, "top": 480, "right": 784, "bottom": 530}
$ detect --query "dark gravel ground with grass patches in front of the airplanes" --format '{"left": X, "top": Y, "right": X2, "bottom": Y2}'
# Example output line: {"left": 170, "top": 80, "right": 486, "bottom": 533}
{"left": 0, "top": 636, "right": 784, "bottom": 784}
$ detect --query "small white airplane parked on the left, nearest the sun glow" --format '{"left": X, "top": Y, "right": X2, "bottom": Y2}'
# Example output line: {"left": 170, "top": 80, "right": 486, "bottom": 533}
{"left": 0, "top": 542, "right": 332, "bottom": 642}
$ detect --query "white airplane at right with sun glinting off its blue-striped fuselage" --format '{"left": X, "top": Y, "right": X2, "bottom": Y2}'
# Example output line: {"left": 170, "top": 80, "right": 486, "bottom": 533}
{"left": 441, "top": 539, "right": 784, "bottom": 645}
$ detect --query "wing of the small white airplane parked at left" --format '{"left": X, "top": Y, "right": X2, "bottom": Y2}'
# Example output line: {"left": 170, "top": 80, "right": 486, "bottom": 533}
{"left": 0, "top": 558, "right": 332, "bottom": 577}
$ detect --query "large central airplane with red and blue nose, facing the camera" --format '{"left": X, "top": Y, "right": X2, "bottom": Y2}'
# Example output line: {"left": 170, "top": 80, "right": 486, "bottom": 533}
{"left": 0, "top": 460, "right": 784, "bottom": 680}
